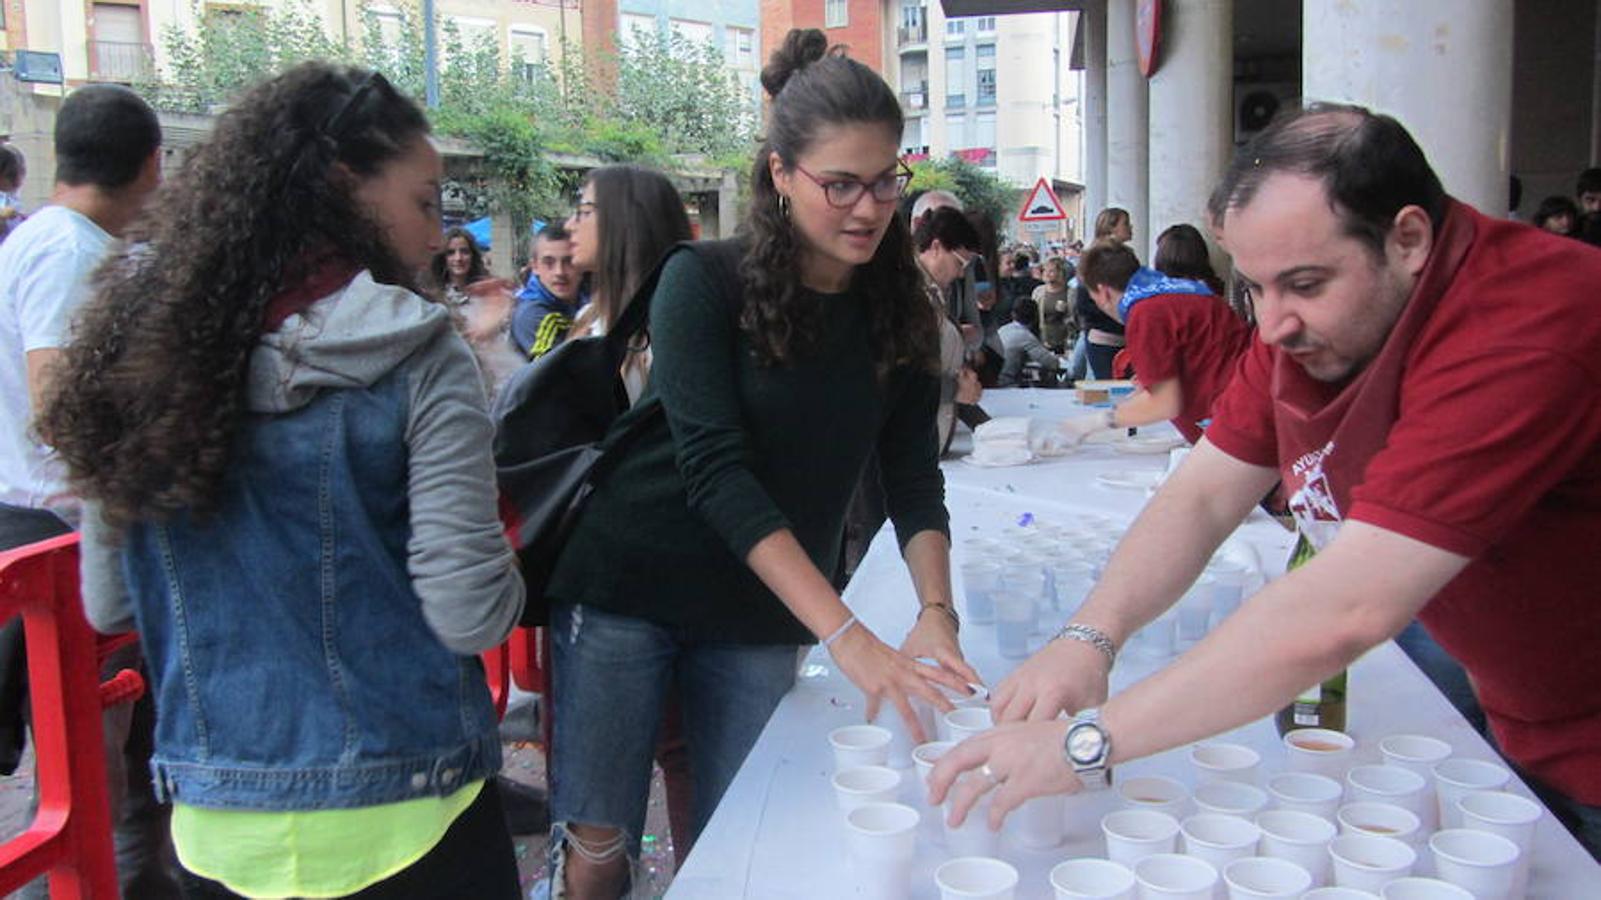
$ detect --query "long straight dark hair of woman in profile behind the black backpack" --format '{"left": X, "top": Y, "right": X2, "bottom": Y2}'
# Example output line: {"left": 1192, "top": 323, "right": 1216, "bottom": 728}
{"left": 584, "top": 165, "right": 693, "bottom": 327}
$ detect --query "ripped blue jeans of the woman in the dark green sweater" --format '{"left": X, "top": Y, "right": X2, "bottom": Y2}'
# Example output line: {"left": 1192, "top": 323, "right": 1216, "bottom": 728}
{"left": 549, "top": 604, "right": 799, "bottom": 863}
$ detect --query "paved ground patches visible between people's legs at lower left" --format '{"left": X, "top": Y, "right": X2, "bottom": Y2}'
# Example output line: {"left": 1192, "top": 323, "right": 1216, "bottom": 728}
{"left": 0, "top": 695, "right": 672, "bottom": 897}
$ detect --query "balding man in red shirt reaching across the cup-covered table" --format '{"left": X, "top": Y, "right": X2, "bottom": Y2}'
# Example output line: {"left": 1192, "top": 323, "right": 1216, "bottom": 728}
{"left": 930, "top": 104, "right": 1601, "bottom": 854}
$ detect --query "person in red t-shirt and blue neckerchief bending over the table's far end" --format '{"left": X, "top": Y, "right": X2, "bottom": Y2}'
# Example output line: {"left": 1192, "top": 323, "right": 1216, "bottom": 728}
{"left": 1061, "top": 243, "right": 1250, "bottom": 444}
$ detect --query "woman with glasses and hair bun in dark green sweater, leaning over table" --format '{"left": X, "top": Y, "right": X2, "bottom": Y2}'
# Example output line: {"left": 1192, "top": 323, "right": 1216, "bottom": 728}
{"left": 549, "top": 30, "right": 977, "bottom": 898}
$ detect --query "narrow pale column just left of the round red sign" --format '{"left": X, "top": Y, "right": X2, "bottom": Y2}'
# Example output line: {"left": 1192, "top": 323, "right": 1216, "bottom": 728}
{"left": 1107, "top": 0, "right": 1150, "bottom": 247}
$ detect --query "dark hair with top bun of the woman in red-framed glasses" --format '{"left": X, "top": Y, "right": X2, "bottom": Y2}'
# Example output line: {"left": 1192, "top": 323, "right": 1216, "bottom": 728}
{"left": 740, "top": 29, "right": 940, "bottom": 376}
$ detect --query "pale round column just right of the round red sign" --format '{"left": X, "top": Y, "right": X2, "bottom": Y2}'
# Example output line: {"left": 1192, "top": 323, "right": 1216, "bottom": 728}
{"left": 1135, "top": 0, "right": 1234, "bottom": 261}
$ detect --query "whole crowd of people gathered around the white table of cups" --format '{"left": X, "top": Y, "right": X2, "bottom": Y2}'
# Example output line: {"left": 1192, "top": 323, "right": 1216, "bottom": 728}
{"left": 0, "top": 21, "right": 1601, "bottom": 898}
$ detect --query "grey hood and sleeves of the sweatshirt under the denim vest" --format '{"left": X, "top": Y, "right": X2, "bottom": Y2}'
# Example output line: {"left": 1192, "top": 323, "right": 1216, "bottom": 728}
{"left": 82, "top": 272, "right": 524, "bottom": 655}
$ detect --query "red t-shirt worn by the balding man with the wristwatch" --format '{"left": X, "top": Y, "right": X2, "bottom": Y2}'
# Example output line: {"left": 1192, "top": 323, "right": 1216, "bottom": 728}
{"left": 1207, "top": 203, "right": 1601, "bottom": 804}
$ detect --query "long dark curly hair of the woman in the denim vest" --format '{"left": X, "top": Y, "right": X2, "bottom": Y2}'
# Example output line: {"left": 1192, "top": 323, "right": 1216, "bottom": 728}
{"left": 40, "top": 62, "right": 427, "bottom": 527}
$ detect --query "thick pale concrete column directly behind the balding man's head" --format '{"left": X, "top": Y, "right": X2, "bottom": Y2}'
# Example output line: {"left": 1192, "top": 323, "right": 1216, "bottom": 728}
{"left": 1302, "top": 0, "right": 1513, "bottom": 216}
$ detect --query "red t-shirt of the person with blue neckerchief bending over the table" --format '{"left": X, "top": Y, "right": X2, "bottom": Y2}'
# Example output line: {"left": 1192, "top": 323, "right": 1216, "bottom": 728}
{"left": 1117, "top": 293, "right": 1250, "bottom": 444}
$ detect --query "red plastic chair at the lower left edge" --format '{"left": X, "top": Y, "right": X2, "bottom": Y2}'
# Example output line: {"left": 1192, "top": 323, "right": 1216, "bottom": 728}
{"left": 0, "top": 535, "right": 144, "bottom": 900}
